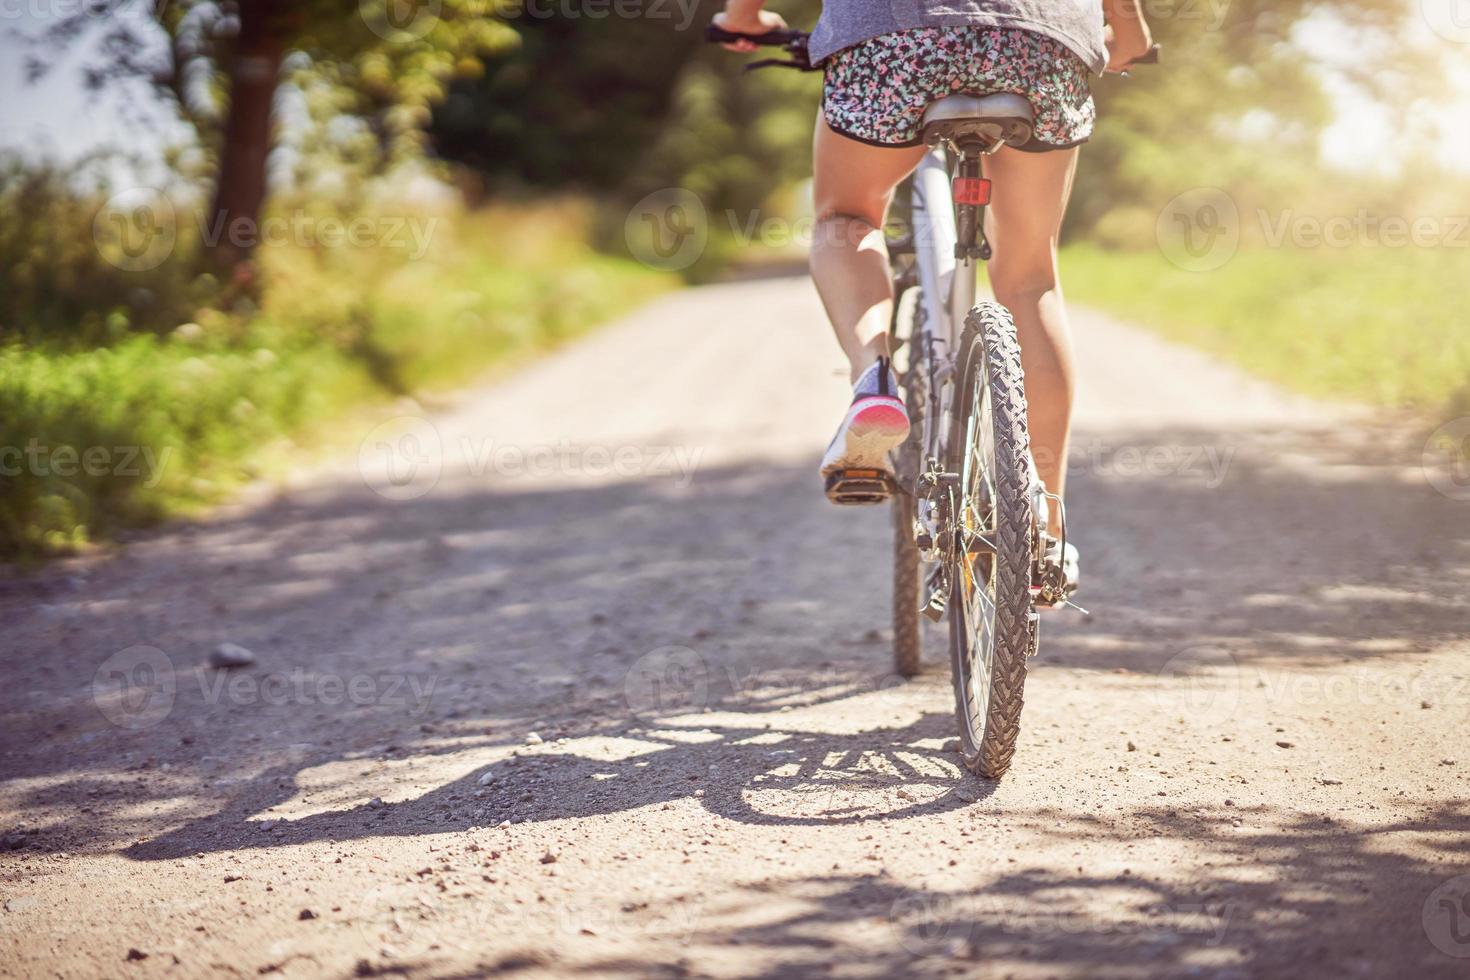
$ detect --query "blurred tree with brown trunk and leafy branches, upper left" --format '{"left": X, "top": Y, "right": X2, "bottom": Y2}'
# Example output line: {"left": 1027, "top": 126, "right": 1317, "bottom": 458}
{"left": 28, "top": 0, "right": 516, "bottom": 273}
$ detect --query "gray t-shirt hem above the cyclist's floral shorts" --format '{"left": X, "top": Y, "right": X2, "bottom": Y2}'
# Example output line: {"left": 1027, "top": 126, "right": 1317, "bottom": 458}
{"left": 810, "top": 0, "right": 1107, "bottom": 75}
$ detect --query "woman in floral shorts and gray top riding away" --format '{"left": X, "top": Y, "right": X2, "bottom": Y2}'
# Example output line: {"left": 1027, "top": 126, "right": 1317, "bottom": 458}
{"left": 714, "top": 0, "right": 1152, "bottom": 593}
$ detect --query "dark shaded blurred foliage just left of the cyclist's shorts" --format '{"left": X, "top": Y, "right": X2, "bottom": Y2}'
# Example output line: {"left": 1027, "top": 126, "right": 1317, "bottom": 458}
{"left": 431, "top": 0, "right": 820, "bottom": 220}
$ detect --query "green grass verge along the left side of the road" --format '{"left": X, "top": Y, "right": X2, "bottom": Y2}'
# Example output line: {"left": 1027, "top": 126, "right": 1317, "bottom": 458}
{"left": 0, "top": 206, "right": 675, "bottom": 560}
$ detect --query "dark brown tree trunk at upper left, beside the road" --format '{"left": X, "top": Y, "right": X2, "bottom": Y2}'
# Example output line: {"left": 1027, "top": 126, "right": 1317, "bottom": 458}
{"left": 204, "top": 0, "right": 285, "bottom": 288}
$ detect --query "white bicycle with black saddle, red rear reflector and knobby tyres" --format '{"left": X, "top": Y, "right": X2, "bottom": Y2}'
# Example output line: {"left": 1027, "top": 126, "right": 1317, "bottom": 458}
{"left": 706, "top": 25, "right": 1158, "bottom": 779}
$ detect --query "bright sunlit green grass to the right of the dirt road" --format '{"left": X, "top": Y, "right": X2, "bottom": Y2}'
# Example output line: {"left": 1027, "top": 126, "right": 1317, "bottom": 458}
{"left": 1061, "top": 245, "right": 1470, "bottom": 414}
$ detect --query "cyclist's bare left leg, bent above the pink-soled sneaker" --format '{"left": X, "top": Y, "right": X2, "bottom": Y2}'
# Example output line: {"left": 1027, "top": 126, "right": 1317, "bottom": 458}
{"left": 811, "top": 116, "right": 923, "bottom": 382}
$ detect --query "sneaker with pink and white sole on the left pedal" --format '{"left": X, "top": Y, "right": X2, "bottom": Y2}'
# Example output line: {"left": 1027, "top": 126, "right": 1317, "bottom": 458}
{"left": 822, "top": 357, "right": 908, "bottom": 504}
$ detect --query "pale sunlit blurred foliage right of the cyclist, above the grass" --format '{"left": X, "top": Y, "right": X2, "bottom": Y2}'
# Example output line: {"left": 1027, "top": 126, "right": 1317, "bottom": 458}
{"left": 1067, "top": 0, "right": 1454, "bottom": 241}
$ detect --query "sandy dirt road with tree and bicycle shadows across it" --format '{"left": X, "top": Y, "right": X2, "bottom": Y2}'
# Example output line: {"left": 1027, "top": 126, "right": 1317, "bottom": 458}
{"left": 0, "top": 279, "right": 1470, "bottom": 980}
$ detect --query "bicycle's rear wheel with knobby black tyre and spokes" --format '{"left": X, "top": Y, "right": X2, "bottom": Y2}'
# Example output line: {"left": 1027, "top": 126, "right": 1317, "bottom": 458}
{"left": 947, "top": 303, "right": 1036, "bottom": 779}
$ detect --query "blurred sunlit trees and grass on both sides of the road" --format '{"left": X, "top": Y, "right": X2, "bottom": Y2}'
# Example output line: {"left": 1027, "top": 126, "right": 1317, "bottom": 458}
{"left": 0, "top": 0, "right": 1470, "bottom": 561}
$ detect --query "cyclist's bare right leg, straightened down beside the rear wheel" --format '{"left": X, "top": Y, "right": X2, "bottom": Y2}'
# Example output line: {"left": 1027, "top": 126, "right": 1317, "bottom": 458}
{"left": 985, "top": 147, "right": 1078, "bottom": 527}
